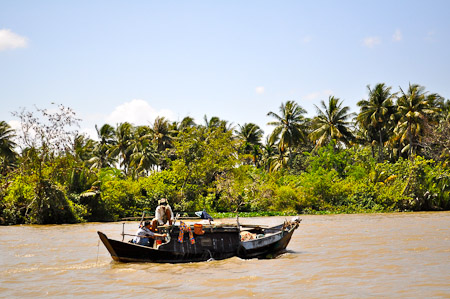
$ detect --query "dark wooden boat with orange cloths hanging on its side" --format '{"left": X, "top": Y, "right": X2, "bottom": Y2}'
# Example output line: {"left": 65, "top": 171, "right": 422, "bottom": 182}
{"left": 97, "top": 217, "right": 301, "bottom": 263}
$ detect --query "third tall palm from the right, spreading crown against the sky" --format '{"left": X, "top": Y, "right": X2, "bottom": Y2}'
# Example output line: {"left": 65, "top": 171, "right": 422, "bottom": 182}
{"left": 309, "top": 96, "right": 354, "bottom": 149}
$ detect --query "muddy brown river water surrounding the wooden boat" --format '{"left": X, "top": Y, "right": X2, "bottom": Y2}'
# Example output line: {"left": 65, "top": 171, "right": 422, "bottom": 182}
{"left": 0, "top": 212, "right": 450, "bottom": 298}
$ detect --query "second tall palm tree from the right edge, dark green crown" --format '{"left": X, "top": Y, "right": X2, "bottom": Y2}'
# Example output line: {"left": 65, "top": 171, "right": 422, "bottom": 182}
{"left": 356, "top": 83, "right": 395, "bottom": 161}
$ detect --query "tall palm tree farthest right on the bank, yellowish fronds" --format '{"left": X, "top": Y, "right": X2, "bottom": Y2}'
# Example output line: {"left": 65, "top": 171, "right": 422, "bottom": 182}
{"left": 394, "top": 84, "right": 440, "bottom": 158}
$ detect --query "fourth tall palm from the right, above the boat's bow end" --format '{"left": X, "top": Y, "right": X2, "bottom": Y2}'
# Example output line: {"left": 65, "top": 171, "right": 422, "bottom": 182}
{"left": 267, "top": 101, "right": 307, "bottom": 153}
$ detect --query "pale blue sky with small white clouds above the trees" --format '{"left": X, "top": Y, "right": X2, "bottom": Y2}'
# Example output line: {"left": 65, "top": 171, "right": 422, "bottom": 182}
{"left": 0, "top": 0, "right": 450, "bottom": 137}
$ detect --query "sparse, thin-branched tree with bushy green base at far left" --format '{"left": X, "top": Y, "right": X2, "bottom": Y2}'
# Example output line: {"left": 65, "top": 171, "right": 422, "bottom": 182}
{"left": 7, "top": 105, "right": 79, "bottom": 224}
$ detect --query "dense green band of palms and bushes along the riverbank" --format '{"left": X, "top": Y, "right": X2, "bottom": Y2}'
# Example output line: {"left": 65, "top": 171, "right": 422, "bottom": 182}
{"left": 0, "top": 84, "right": 450, "bottom": 224}
